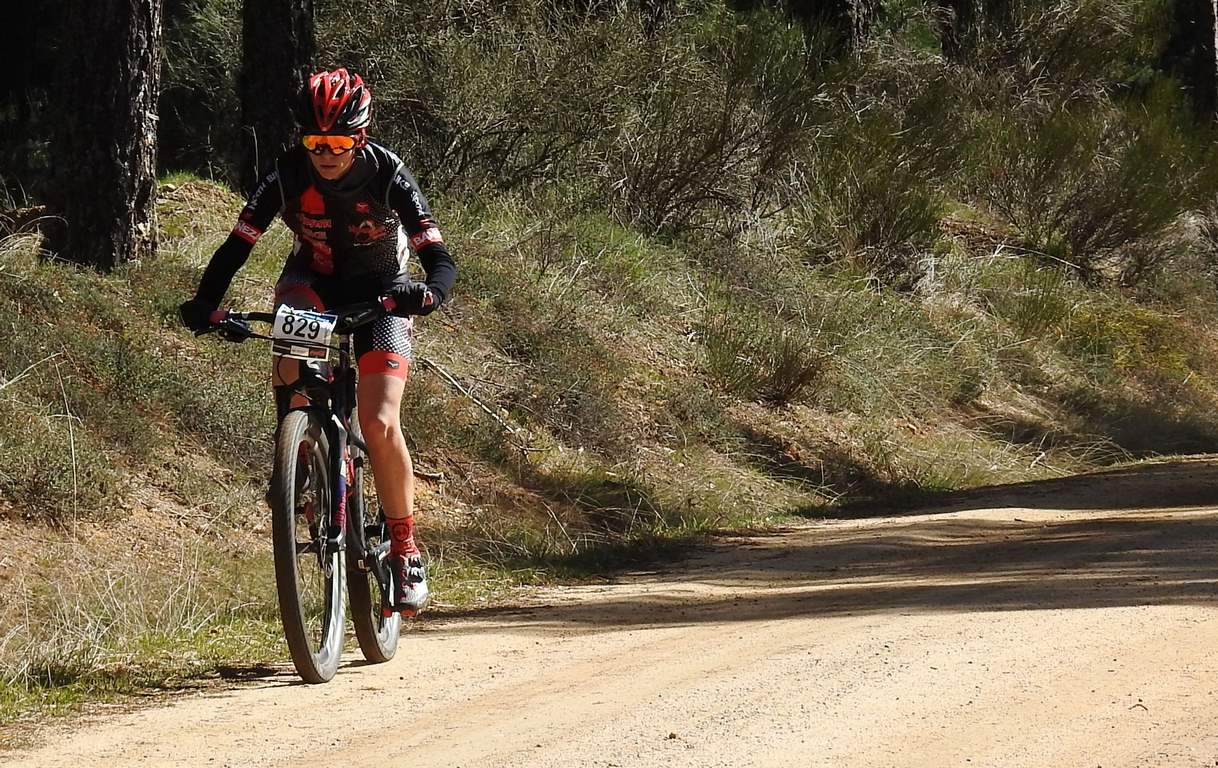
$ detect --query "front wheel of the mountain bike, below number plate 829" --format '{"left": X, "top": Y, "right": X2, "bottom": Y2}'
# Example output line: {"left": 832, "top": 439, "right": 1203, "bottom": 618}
{"left": 270, "top": 409, "right": 346, "bottom": 683}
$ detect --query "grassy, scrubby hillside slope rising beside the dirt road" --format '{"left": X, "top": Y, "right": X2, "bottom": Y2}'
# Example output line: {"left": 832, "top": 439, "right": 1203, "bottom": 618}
{"left": 0, "top": 178, "right": 1218, "bottom": 735}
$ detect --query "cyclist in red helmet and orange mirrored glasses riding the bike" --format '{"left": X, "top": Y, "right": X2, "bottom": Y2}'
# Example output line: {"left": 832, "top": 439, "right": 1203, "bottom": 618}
{"left": 180, "top": 67, "right": 457, "bottom": 616}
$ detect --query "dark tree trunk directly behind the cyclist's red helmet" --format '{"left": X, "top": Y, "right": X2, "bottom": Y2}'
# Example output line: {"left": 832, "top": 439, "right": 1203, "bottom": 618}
{"left": 239, "top": 0, "right": 313, "bottom": 192}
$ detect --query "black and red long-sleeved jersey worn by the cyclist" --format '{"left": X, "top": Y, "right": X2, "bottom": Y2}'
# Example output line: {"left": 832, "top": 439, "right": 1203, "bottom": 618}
{"left": 197, "top": 141, "right": 457, "bottom": 304}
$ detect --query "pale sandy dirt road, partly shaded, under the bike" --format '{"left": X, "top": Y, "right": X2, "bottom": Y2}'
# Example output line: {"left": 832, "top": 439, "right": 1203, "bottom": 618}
{"left": 7, "top": 463, "right": 1218, "bottom": 768}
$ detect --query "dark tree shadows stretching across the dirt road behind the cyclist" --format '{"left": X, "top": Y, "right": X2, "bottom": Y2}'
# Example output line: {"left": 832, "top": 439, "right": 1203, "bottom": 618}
{"left": 445, "top": 461, "right": 1218, "bottom": 632}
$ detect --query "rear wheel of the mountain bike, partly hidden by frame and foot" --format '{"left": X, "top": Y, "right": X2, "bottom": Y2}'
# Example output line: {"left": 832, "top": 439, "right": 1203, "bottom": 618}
{"left": 347, "top": 413, "right": 402, "bottom": 665}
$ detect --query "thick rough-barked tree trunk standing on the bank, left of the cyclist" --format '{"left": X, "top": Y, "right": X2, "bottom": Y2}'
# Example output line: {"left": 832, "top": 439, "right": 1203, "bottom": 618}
{"left": 45, "top": 0, "right": 161, "bottom": 270}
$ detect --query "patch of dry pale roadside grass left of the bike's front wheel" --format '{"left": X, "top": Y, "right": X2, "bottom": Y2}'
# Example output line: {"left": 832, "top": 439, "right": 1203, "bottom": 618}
{"left": 0, "top": 537, "right": 283, "bottom": 724}
